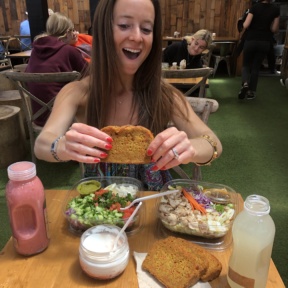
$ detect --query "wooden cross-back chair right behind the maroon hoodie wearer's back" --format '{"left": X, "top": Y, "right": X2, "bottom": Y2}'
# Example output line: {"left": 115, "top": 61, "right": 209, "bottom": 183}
{"left": 5, "top": 71, "right": 80, "bottom": 163}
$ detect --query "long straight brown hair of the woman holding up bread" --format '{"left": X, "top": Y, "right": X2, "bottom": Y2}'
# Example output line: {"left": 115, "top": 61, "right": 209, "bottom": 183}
{"left": 87, "top": 0, "right": 187, "bottom": 135}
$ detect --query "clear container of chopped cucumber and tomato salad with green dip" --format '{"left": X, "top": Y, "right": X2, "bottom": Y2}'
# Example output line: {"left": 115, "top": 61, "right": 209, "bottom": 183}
{"left": 63, "top": 176, "right": 145, "bottom": 234}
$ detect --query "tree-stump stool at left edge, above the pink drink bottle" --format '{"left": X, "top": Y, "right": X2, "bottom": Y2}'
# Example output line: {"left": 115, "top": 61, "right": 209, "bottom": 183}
{"left": 0, "top": 105, "right": 27, "bottom": 168}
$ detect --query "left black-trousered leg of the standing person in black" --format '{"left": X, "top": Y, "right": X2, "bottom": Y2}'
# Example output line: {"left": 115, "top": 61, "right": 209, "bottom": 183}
{"left": 238, "top": 41, "right": 253, "bottom": 99}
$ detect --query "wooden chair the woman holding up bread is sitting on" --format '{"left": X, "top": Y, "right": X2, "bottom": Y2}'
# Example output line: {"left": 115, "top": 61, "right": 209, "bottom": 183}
{"left": 171, "top": 97, "right": 219, "bottom": 180}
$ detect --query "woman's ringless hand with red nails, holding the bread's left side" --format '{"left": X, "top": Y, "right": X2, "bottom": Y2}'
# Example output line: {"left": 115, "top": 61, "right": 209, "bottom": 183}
{"left": 57, "top": 123, "right": 113, "bottom": 163}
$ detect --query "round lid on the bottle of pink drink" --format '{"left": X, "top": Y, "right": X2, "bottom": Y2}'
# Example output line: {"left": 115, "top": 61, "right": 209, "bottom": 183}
{"left": 7, "top": 161, "right": 36, "bottom": 181}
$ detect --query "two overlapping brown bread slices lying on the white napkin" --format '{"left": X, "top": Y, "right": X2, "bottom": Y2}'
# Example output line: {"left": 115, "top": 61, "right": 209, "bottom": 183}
{"left": 142, "top": 236, "right": 222, "bottom": 288}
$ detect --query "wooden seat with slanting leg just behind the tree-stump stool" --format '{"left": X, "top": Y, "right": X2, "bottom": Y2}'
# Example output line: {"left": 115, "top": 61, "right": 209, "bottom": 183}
{"left": 0, "top": 90, "right": 29, "bottom": 139}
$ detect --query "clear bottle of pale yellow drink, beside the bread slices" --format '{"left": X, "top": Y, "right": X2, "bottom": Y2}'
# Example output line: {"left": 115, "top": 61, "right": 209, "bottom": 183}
{"left": 227, "top": 195, "right": 275, "bottom": 288}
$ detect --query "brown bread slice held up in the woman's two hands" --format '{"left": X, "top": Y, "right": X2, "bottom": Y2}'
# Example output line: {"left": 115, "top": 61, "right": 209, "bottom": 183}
{"left": 101, "top": 125, "right": 154, "bottom": 164}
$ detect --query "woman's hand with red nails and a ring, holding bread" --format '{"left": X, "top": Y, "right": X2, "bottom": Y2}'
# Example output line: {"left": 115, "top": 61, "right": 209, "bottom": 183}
{"left": 147, "top": 127, "right": 195, "bottom": 170}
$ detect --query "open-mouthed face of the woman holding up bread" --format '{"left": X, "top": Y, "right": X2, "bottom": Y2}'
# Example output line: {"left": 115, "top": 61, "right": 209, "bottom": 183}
{"left": 113, "top": 0, "right": 155, "bottom": 75}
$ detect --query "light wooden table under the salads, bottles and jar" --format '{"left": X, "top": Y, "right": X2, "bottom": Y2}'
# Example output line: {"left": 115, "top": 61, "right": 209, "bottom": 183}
{"left": 0, "top": 190, "right": 285, "bottom": 288}
